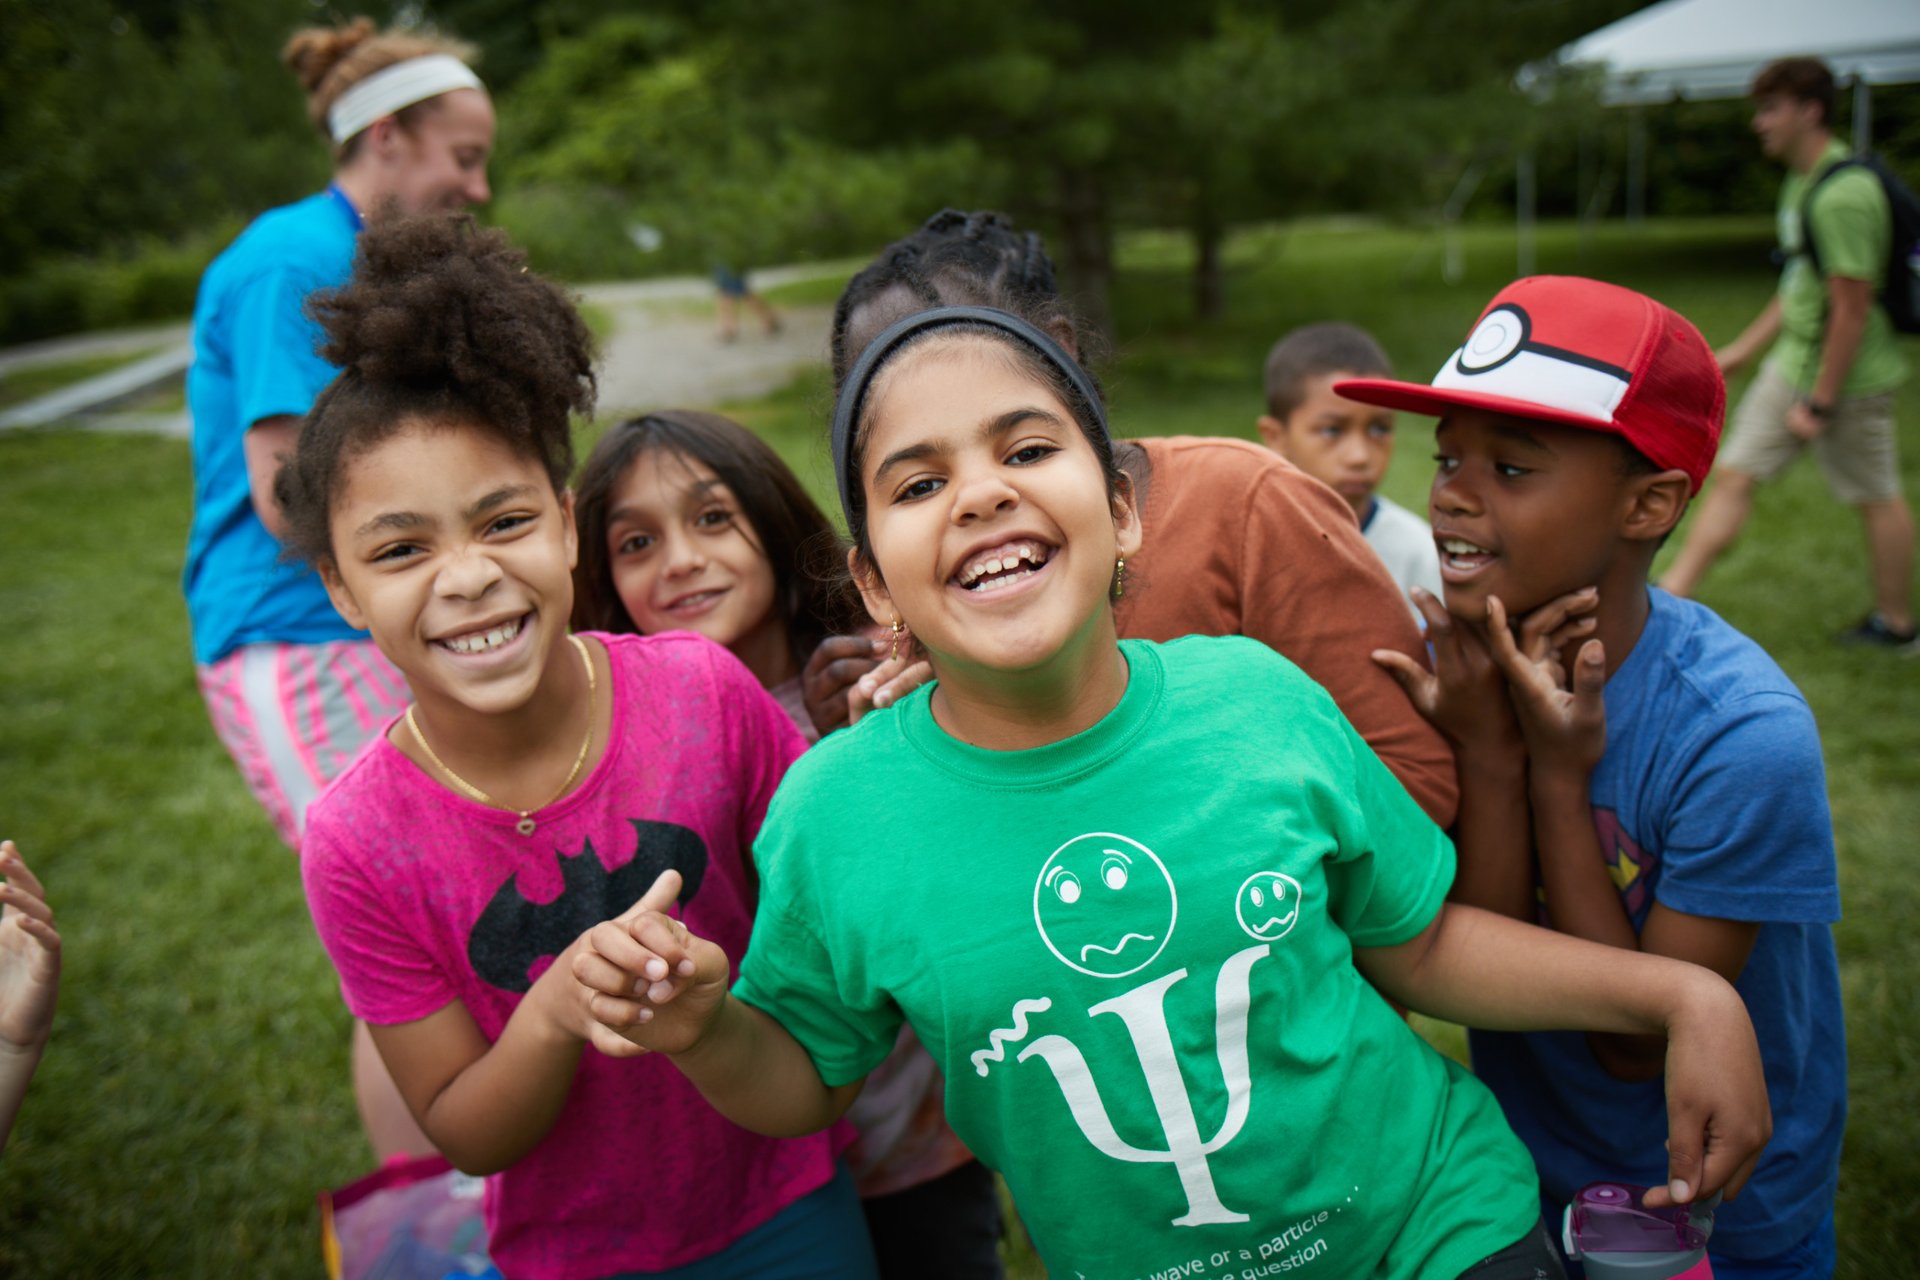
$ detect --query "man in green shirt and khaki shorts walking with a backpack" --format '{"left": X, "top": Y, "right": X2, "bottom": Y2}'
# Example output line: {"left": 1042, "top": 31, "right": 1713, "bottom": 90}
{"left": 1661, "top": 58, "right": 1916, "bottom": 652}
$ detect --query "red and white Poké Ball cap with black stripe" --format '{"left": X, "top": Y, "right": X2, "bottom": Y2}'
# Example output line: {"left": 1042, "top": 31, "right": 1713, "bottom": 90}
{"left": 1332, "top": 276, "right": 1726, "bottom": 493}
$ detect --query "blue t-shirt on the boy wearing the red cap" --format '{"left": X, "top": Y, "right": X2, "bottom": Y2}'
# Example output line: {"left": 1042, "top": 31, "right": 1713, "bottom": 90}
{"left": 1473, "top": 589, "right": 1847, "bottom": 1259}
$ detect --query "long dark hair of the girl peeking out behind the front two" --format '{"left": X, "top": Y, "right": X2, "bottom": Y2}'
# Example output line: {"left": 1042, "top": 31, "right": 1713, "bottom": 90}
{"left": 574, "top": 409, "right": 860, "bottom": 666}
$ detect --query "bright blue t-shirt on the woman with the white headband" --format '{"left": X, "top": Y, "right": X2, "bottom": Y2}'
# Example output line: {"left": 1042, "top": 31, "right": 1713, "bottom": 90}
{"left": 180, "top": 186, "right": 361, "bottom": 662}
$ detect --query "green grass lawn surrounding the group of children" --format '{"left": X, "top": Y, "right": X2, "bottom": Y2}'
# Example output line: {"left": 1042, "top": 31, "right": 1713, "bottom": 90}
{"left": 0, "top": 221, "right": 1920, "bottom": 1280}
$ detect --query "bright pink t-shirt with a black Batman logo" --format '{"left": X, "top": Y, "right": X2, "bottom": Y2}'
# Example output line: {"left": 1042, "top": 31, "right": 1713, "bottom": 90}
{"left": 301, "top": 633, "right": 849, "bottom": 1280}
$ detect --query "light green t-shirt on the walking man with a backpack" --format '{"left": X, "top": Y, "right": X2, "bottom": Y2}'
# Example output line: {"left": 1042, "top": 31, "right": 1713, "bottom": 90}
{"left": 1766, "top": 138, "right": 1907, "bottom": 395}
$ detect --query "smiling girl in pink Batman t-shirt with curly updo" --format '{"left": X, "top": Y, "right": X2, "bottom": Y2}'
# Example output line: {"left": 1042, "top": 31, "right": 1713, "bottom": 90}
{"left": 276, "top": 217, "right": 874, "bottom": 1280}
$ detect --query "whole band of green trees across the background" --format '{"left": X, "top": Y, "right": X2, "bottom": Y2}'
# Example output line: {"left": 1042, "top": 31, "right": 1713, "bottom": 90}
{"left": 18, "top": 0, "right": 1920, "bottom": 338}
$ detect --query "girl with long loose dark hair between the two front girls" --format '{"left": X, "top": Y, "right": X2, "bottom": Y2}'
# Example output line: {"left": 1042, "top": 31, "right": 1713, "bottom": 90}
{"left": 574, "top": 409, "right": 1000, "bottom": 1280}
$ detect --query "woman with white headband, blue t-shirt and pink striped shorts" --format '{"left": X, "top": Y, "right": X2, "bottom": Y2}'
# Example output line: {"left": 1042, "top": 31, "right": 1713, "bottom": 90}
{"left": 182, "top": 19, "right": 493, "bottom": 1159}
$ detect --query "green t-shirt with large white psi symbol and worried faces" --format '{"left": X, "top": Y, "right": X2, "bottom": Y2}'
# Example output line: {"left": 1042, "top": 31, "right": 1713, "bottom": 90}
{"left": 735, "top": 637, "right": 1540, "bottom": 1280}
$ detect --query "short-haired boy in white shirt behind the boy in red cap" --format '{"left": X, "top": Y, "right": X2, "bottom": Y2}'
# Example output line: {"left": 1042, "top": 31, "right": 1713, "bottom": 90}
{"left": 1260, "top": 324, "right": 1440, "bottom": 618}
